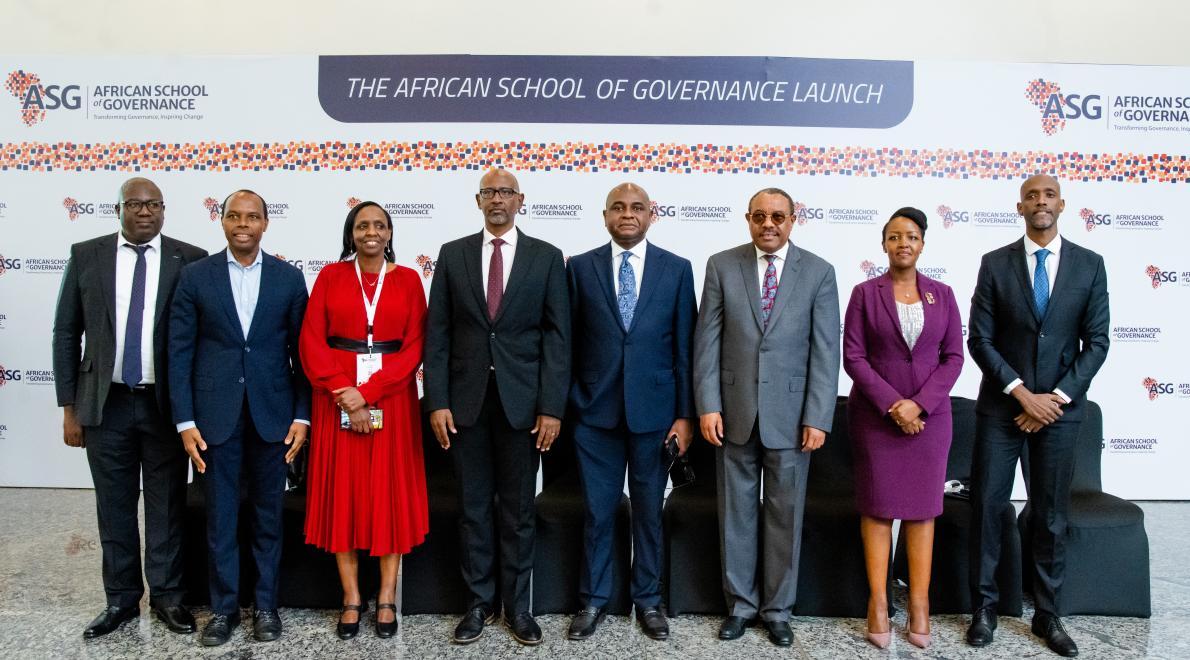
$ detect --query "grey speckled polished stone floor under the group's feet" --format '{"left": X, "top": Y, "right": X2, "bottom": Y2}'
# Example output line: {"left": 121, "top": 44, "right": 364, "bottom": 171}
{"left": 0, "top": 489, "right": 1190, "bottom": 660}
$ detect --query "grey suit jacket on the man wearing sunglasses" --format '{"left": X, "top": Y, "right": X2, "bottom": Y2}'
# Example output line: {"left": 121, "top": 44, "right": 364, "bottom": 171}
{"left": 694, "top": 243, "right": 839, "bottom": 450}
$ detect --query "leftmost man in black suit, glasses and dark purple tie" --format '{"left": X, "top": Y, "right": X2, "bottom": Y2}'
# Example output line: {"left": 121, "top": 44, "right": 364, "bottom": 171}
{"left": 54, "top": 177, "right": 207, "bottom": 639}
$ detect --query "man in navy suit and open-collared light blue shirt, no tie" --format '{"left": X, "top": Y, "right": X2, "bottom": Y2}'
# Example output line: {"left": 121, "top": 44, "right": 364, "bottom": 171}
{"left": 169, "top": 190, "right": 309, "bottom": 646}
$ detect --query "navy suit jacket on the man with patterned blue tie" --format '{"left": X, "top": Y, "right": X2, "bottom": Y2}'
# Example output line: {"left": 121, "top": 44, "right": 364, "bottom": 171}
{"left": 566, "top": 243, "right": 697, "bottom": 433}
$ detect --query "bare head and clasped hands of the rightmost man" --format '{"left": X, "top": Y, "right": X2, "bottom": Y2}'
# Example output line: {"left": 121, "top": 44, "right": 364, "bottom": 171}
{"left": 1009, "top": 174, "right": 1066, "bottom": 433}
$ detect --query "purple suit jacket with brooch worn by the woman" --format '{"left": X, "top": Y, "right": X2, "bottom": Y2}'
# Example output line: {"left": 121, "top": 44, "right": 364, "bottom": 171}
{"left": 843, "top": 272, "right": 963, "bottom": 418}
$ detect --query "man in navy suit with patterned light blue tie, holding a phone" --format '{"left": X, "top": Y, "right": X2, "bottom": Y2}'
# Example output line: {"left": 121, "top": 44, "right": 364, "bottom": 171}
{"left": 566, "top": 183, "right": 697, "bottom": 640}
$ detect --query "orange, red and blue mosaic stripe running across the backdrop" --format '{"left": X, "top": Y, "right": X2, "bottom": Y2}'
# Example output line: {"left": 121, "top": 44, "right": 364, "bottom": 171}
{"left": 0, "top": 140, "right": 1190, "bottom": 183}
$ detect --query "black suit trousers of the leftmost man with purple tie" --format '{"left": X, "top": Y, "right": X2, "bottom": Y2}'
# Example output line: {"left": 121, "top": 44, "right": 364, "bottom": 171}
{"left": 83, "top": 383, "right": 187, "bottom": 608}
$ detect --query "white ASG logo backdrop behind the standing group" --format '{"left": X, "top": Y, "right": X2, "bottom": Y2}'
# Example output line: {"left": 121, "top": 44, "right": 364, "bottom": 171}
{"left": 0, "top": 55, "right": 1190, "bottom": 499}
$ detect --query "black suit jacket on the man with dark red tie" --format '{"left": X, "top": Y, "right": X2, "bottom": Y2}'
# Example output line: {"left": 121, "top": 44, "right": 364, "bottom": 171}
{"left": 424, "top": 230, "right": 570, "bottom": 429}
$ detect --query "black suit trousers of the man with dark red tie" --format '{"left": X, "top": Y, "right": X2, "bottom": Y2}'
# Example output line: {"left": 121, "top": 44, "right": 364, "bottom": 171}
{"left": 450, "top": 375, "right": 539, "bottom": 618}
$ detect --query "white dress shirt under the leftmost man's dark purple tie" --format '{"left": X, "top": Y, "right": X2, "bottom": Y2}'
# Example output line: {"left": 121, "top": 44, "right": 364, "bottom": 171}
{"left": 112, "top": 233, "right": 161, "bottom": 385}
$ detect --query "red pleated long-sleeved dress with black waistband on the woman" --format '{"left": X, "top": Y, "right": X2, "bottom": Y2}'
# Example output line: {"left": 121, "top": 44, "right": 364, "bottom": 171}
{"left": 301, "top": 262, "right": 430, "bottom": 557}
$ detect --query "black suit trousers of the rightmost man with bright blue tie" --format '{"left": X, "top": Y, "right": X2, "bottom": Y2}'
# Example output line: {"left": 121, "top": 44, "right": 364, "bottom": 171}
{"left": 970, "top": 415, "right": 1081, "bottom": 614}
